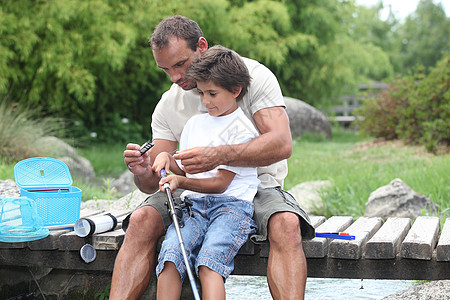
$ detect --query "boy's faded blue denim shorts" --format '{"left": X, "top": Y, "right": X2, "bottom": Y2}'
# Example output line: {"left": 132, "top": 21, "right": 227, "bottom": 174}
{"left": 156, "top": 196, "right": 256, "bottom": 281}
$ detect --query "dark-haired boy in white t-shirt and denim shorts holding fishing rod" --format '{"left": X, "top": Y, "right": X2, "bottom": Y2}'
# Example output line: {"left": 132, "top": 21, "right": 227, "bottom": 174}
{"left": 153, "top": 46, "right": 259, "bottom": 299}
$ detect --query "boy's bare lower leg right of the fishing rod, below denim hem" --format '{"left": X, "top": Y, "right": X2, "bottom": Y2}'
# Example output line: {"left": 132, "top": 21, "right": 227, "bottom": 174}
{"left": 198, "top": 266, "right": 225, "bottom": 300}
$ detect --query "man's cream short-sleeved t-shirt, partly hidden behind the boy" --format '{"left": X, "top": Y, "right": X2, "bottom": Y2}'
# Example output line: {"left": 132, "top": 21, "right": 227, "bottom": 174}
{"left": 151, "top": 57, "right": 288, "bottom": 188}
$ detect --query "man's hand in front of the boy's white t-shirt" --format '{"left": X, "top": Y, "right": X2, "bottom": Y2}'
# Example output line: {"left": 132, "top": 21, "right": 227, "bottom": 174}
{"left": 173, "top": 147, "right": 223, "bottom": 174}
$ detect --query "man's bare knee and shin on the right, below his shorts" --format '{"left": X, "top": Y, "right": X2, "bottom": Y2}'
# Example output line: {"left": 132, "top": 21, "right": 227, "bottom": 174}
{"left": 267, "top": 212, "right": 307, "bottom": 300}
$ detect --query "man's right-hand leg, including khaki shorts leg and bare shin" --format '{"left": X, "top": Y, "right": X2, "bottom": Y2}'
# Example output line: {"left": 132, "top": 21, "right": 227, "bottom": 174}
{"left": 251, "top": 188, "right": 314, "bottom": 299}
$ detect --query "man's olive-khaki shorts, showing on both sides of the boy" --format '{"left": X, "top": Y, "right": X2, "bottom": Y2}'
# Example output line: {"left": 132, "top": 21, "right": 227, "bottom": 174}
{"left": 122, "top": 187, "right": 315, "bottom": 243}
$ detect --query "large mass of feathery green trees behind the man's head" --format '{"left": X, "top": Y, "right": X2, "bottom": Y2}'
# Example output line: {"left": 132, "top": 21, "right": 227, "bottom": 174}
{"left": 0, "top": 0, "right": 400, "bottom": 142}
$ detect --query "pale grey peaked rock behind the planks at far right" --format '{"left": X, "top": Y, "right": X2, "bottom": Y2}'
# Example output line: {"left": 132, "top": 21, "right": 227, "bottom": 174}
{"left": 364, "top": 178, "right": 439, "bottom": 220}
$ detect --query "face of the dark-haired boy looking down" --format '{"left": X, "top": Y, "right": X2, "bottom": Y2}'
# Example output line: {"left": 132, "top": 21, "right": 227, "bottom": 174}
{"left": 197, "top": 81, "right": 241, "bottom": 117}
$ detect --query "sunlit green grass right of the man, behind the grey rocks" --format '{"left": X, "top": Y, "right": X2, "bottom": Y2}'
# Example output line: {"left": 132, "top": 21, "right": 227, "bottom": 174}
{"left": 285, "top": 128, "right": 450, "bottom": 217}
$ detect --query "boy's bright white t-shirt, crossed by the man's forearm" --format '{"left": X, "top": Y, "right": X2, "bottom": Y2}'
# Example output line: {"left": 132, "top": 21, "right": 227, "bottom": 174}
{"left": 178, "top": 108, "right": 259, "bottom": 202}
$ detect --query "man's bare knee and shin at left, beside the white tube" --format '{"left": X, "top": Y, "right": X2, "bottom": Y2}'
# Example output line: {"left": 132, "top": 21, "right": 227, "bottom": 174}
{"left": 109, "top": 206, "right": 164, "bottom": 300}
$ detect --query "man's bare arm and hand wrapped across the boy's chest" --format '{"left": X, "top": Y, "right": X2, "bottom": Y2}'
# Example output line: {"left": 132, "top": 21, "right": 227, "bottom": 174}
{"left": 174, "top": 106, "right": 292, "bottom": 174}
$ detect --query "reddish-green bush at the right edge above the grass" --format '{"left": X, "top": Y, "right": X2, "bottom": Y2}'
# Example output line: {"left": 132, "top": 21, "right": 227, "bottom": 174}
{"left": 357, "top": 55, "right": 450, "bottom": 151}
